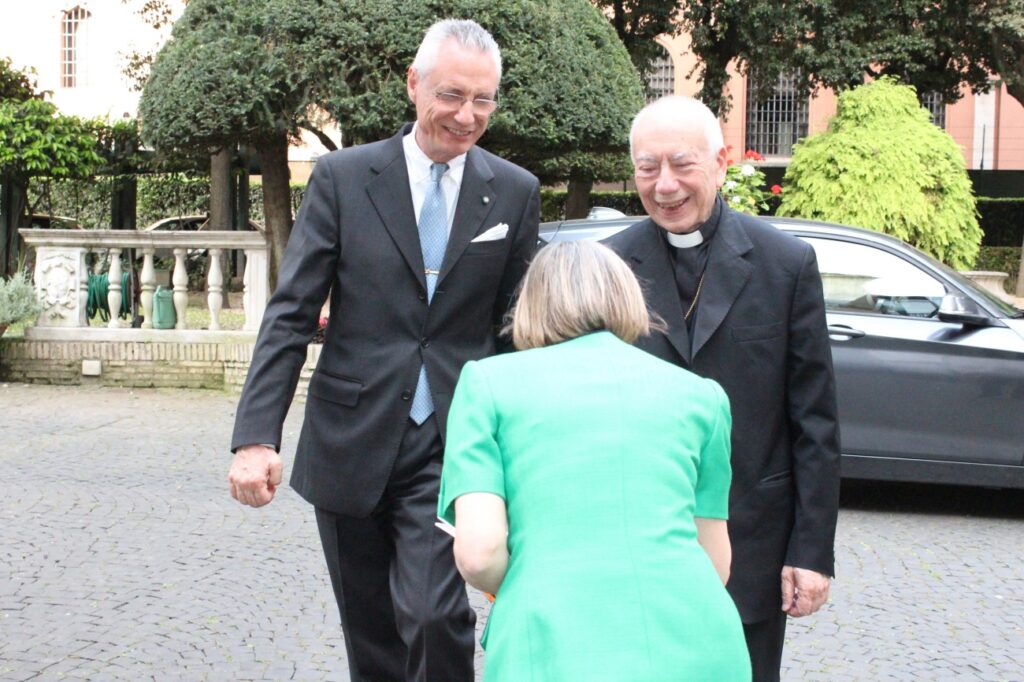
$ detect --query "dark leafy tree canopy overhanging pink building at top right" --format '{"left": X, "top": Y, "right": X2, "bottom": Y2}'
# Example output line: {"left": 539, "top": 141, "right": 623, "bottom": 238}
{"left": 680, "top": 0, "right": 1024, "bottom": 112}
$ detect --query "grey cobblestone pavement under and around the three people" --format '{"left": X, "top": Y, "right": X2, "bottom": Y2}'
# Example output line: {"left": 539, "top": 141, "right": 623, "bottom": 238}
{"left": 0, "top": 384, "right": 1024, "bottom": 682}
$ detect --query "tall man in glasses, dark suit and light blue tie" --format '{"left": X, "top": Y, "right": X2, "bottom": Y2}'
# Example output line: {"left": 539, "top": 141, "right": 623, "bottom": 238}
{"left": 229, "top": 20, "right": 540, "bottom": 682}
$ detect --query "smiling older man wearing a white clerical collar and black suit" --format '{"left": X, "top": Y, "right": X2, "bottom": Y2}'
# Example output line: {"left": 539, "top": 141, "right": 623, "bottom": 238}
{"left": 608, "top": 97, "right": 839, "bottom": 680}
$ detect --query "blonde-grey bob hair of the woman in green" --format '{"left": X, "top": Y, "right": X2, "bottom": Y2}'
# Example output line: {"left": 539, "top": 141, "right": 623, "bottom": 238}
{"left": 506, "top": 241, "right": 656, "bottom": 350}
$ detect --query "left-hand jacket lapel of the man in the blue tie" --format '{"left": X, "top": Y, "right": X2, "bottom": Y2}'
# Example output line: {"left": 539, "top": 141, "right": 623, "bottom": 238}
{"left": 367, "top": 126, "right": 427, "bottom": 289}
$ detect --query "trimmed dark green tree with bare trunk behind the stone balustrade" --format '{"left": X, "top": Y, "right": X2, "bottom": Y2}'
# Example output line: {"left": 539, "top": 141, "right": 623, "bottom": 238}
{"left": 139, "top": 0, "right": 315, "bottom": 287}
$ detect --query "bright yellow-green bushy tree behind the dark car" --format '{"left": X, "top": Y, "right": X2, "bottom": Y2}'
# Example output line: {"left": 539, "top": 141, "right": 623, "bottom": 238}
{"left": 778, "top": 77, "right": 982, "bottom": 269}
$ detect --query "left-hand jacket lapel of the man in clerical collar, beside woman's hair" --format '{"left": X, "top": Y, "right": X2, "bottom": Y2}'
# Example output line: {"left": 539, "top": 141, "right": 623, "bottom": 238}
{"left": 629, "top": 218, "right": 690, "bottom": 366}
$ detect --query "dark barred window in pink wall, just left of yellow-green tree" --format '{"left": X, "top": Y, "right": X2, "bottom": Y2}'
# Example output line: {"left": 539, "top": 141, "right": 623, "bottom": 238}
{"left": 745, "top": 71, "right": 808, "bottom": 157}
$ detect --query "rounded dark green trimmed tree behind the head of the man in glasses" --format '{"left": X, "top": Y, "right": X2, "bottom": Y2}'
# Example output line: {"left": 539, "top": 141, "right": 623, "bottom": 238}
{"left": 306, "top": 0, "right": 643, "bottom": 216}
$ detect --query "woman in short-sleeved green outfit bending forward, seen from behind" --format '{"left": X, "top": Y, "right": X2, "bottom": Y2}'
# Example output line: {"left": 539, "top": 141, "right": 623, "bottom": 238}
{"left": 438, "top": 242, "right": 751, "bottom": 682}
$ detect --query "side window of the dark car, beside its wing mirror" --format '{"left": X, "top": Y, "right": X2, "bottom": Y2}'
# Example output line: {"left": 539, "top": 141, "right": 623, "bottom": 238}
{"left": 803, "top": 237, "right": 946, "bottom": 317}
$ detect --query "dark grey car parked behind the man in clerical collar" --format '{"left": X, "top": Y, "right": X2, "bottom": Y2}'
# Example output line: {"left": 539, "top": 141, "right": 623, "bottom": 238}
{"left": 541, "top": 217, "right": 1024, "bottom": 488}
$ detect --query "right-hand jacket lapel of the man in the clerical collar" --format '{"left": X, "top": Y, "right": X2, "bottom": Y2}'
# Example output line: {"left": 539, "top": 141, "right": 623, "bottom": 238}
{"left": 693, "top": 208, "right": 754, "bottom": 357}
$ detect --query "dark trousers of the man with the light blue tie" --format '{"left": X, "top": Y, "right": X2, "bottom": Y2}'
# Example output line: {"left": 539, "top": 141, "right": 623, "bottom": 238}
{"left": 316, "top": 417, "right": 476, "bottom": 682}
